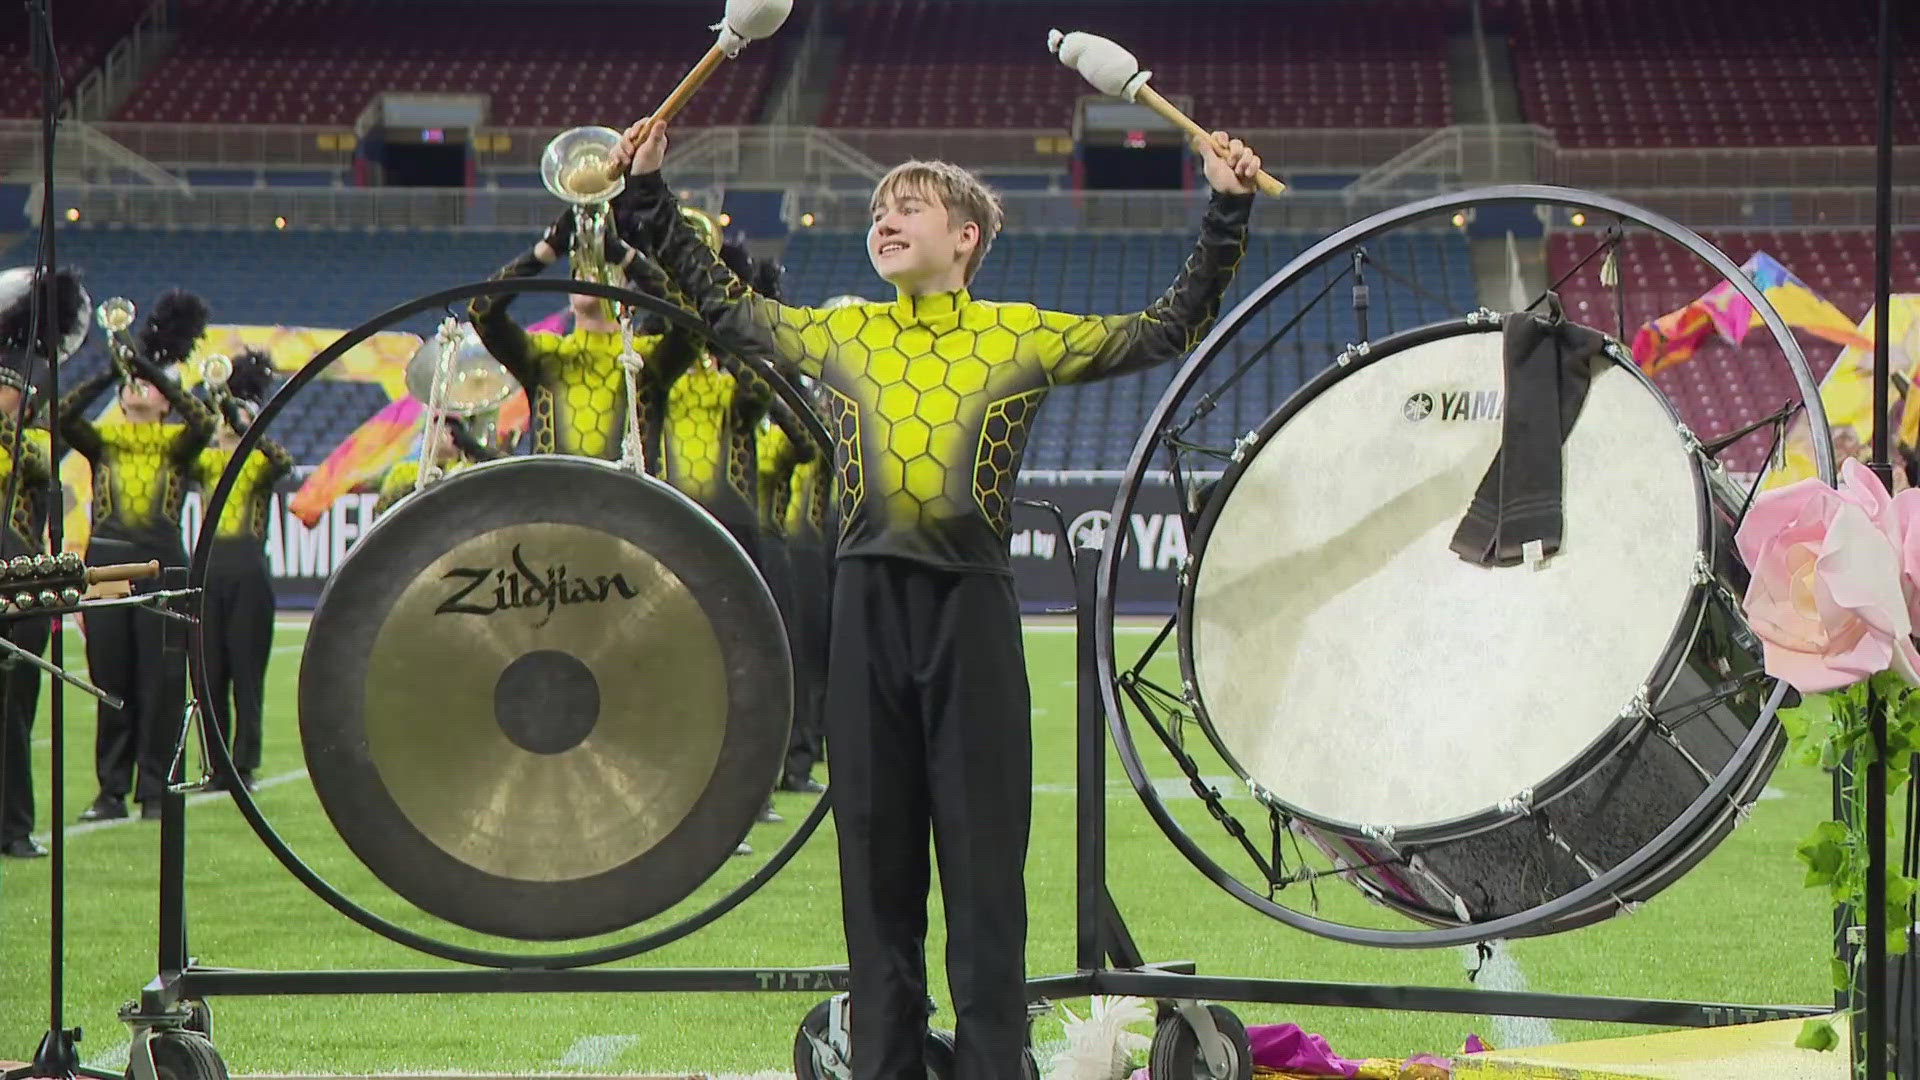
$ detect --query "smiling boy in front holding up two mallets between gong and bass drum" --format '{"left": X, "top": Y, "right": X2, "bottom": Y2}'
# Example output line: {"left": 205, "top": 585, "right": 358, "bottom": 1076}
{"left": 618, "top": 121, "right": 1260, "bottom": 1080}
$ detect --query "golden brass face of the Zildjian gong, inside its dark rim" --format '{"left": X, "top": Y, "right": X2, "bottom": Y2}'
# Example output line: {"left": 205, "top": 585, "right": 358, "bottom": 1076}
{"left": 367, "top": 523, "right": 726, "bottom": 882}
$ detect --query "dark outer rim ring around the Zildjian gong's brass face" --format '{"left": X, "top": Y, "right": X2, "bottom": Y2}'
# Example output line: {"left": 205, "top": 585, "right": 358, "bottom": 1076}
{"left": 298, "top": 454, "right": 791, "bottom": 942}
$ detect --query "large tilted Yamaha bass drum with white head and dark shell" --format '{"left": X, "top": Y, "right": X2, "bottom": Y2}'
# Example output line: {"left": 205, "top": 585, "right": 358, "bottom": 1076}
{"left": 1181, "top": 311, "right": 1780, "bottom": 934}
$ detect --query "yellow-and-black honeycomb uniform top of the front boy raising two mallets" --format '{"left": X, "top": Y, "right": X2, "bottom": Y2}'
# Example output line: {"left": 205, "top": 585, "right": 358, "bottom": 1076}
{"left": 630, "top": 173, "right": 1252, "bottom": 575}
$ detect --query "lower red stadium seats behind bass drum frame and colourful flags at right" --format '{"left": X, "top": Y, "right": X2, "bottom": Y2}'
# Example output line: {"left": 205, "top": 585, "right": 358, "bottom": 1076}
{"left": 1548, "top": 231, "right": 1920, "bottom": 469}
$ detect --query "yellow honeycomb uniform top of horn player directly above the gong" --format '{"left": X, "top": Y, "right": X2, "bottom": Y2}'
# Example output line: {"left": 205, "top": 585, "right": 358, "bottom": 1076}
{"left": 467, "top": 252, "right": 695, "bottom": 465}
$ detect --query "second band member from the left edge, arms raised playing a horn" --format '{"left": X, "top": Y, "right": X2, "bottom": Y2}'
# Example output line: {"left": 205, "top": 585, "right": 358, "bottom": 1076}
{"left": 60, "top": 290, "right": 213, "bottom": 821}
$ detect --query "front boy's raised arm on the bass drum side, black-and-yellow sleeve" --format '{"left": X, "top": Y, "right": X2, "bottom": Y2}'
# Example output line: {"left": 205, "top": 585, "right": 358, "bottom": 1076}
{"left": 1041, "top": 192, "right": 1254, "bottom": 382}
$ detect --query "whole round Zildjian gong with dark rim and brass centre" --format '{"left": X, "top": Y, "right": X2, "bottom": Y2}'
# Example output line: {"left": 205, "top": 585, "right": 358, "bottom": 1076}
{"left": 300, "top": 455, "right": 793, "bottom": 940}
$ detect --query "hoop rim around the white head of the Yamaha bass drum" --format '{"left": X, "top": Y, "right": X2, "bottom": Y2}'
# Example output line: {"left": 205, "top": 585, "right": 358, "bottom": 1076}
{"left": 1177, "top": 307, "right": 1720, "bottom": 844}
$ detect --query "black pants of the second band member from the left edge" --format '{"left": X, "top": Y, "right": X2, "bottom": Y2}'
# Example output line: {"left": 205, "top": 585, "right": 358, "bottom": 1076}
{"left": 86, "top": 538, "right": 186, "bottom": 803}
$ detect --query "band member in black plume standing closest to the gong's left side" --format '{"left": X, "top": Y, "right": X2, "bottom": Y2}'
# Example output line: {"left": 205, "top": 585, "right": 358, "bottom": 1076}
{"left": 194, "top": 350, "right": 294, "bottom": 790}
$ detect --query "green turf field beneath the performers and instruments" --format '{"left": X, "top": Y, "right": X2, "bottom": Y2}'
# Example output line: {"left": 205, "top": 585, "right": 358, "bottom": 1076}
{"left": 0, "top": 625, "right": 1830, "bottom": 1074}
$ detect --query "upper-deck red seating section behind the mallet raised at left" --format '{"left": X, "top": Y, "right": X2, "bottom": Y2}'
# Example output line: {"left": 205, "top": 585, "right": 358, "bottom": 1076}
{"left": 117, "top": 0, "right": 772, "bottom": 127}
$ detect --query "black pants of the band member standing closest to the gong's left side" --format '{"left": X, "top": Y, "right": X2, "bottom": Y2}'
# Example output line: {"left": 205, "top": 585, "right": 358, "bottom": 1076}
{"left": 200, "top": 540, "right": 275, "bottom": 773}
